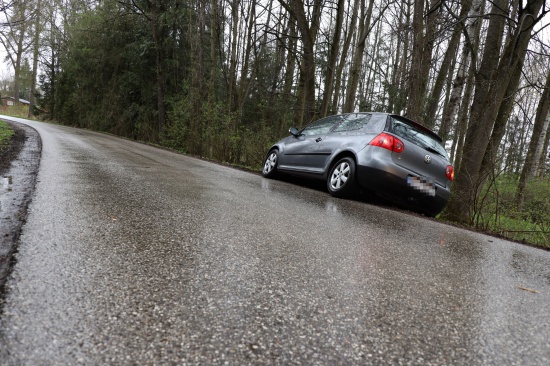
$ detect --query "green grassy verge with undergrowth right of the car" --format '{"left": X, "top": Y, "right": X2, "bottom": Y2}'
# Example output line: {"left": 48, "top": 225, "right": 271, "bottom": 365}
{"left": 474, "top": 175, "right": 550, "bottom": 249}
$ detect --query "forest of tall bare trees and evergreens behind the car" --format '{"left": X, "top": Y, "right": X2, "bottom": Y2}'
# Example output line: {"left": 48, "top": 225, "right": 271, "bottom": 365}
{"left": 0, "top": 0, "right": 550, "bottom": 246}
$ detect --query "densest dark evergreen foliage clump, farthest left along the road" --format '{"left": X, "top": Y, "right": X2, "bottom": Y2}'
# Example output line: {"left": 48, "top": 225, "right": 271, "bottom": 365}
{"left": 41, "top": 1, "right": 184, "bottom": 141}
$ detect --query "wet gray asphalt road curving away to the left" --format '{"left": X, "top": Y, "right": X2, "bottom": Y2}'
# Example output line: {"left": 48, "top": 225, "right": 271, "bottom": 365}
{"left": 0, "top": 118, "right": 550, "bottom": 365}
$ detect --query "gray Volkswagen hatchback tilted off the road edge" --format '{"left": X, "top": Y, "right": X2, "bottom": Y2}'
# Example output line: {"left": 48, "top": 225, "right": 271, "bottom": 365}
{"left": 262, "top": 112, "right": 454, "bottom": 216}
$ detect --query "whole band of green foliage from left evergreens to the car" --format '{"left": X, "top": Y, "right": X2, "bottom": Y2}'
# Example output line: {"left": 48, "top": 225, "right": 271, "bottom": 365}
{"left": 40, "top": 0, "right": 292, "bottom": 159}
